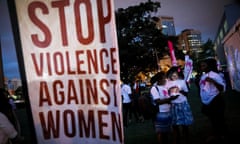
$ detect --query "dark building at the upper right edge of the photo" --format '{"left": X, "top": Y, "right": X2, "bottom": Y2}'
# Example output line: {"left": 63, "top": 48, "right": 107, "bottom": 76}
{"left": 214, "top": 4, "right": 240, "bottom": 68}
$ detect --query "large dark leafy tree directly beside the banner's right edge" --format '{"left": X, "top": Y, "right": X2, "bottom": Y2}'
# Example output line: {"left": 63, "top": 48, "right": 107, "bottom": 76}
{"left": 116, "top": 0, "right": 171, "bottom": 79}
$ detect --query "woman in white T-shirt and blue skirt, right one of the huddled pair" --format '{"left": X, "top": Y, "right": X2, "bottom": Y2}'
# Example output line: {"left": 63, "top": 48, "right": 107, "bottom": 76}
{"left": 167, "top": 67, "right": 193, "bottom": 144}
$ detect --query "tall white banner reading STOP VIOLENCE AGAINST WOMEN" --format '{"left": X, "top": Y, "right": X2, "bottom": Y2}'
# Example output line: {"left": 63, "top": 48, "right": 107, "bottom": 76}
{"left": 15, "top": 0, "right": 124, "bottom": 144}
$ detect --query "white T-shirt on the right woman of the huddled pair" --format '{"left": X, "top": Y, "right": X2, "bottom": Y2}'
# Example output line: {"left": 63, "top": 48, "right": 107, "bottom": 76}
{"left": 166, "top": 79, "right": 188, "bottom": 103}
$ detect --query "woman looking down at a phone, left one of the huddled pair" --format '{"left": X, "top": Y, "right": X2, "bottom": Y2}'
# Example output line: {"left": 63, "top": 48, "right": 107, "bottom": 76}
{"left": 150, "top": 72, "right": 177, "bottom": 144}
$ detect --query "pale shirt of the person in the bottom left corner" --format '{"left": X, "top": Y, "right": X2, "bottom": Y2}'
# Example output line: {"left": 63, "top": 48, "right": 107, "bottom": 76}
{"left": 0, "top": 112, "right": 17, "bottom": 144}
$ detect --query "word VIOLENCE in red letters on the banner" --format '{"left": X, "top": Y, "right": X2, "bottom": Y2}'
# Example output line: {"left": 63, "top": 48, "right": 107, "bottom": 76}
{"left": 31, "top": 48, "right": 118, "bottom": 77}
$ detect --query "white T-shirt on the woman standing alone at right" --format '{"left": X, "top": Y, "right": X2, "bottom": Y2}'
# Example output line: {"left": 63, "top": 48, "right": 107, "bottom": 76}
{"left": 199, "top": 71, "right": 226, "bottom": 105}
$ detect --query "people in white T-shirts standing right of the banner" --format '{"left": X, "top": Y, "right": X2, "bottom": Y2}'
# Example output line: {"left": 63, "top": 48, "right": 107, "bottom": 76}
{"left": 121, "top": 59, "right": 227, "bottom": 144}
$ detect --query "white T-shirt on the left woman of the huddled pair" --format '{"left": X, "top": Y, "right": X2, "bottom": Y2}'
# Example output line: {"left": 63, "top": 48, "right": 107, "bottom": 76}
{"left": 150, "top": 85, "right": 171, "bottom": 112}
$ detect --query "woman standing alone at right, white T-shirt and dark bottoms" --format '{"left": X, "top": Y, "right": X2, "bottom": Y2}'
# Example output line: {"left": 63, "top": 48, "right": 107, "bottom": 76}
{"left": 199, "top": 59, "right": 227, "bottom": 142}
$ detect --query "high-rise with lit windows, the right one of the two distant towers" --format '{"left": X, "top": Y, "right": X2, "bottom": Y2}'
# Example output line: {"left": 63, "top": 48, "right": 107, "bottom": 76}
{"left": 178, "top": 29, "right": 202, "bottom": 59}
